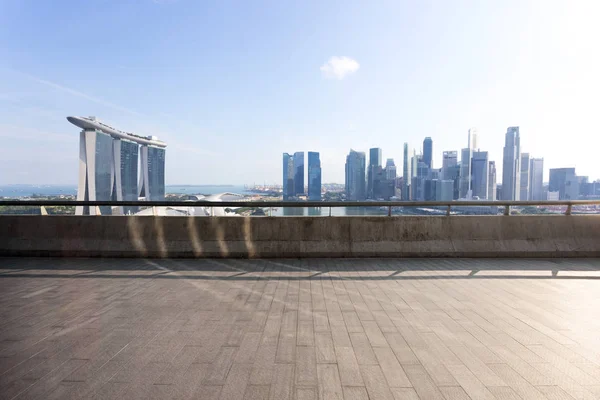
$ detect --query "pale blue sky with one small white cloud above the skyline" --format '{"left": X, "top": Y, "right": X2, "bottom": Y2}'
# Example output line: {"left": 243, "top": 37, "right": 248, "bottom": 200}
{"left": 0, "top": 0, "right": 600, "bottom": 184}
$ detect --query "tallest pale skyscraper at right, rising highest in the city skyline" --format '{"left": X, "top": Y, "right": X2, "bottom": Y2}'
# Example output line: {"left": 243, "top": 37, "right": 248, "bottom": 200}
{"left": 502, "top": 126, "right": 521, "bottom": 200}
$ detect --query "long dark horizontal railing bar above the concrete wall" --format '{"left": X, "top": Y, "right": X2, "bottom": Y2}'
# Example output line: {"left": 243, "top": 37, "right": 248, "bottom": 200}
{"left": 0, "top": 200, "right": 600, "bottom": 208}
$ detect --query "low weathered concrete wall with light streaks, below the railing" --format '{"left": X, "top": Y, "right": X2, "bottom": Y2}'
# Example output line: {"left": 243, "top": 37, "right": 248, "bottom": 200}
{"left": 0, "top": 215, "right": 600, "bottom": 258}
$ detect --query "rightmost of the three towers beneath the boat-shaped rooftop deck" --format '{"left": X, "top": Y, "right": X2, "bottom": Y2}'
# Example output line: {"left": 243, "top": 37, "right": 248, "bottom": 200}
{"left": 139, "top": 145, "right": 165, "bottom": 201}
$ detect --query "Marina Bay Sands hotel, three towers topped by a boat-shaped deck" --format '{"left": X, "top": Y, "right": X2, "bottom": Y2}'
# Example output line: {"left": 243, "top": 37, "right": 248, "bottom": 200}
{"left": 67, "top": 117, "right": 167, "bottom": 215}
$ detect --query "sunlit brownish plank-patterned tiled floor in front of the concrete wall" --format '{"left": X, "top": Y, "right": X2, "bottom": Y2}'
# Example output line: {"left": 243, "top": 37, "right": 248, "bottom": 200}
{"left": 0, "top": 258, "right": 600, "bottom": 400}
